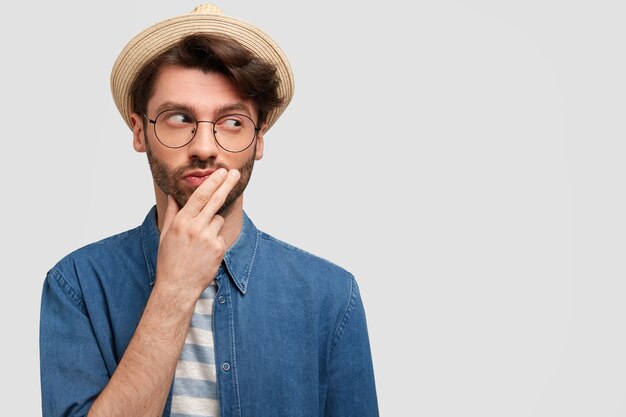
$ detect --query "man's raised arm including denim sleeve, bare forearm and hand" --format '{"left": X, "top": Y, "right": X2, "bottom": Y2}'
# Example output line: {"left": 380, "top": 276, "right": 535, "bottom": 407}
{"left": 40, "top": 170, "right": 239, "bottom": 417}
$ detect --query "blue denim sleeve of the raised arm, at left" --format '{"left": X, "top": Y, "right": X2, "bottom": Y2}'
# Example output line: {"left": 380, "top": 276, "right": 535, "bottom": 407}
{"left": 39, "top": 269, "right": 110, "bottom": 417}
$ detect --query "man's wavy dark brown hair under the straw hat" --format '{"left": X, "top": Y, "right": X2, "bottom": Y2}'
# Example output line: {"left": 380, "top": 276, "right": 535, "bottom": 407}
{"left": 130, "top": 34, "right": 282, "bottom": 126}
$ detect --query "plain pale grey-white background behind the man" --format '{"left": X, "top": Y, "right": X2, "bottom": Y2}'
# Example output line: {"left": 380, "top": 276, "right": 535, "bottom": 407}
{"left": 0, "top": 0, "right": 626, "bottom": 417}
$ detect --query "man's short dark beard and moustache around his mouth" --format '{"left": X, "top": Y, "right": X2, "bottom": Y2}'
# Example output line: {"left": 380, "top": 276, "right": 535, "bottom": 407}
{"left": 145, "top": 140, "right": 256, "bottom": 216}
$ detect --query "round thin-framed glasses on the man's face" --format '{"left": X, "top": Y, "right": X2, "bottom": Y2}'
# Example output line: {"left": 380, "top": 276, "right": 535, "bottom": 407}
{"left": 144, "top": 110, "right": 259, "bottom": 153}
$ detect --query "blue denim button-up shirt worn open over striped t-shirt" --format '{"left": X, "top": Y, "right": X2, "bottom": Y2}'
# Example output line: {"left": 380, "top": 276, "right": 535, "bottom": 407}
{"left": 40, "top": 208, "right": 378, "bottom": 417}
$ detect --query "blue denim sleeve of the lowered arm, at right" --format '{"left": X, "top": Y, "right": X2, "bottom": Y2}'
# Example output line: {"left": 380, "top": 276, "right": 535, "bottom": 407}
{"left": 325, "top": 278, "right": 378, "bottom": 417}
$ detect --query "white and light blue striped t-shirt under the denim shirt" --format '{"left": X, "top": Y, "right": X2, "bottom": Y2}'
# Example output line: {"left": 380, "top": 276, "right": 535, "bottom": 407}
{"left": 171, "top": 281, "right": 219, "bottom": 417}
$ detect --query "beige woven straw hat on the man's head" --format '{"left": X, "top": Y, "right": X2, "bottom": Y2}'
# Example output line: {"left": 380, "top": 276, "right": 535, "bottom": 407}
{"left": 111, "top": 4, "right": 294, "bottom": 129}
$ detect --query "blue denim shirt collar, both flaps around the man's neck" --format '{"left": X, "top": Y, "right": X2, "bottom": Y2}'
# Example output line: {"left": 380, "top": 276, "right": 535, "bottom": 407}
{"left": 141, "top": 206, "right": 259, "bottom": 294}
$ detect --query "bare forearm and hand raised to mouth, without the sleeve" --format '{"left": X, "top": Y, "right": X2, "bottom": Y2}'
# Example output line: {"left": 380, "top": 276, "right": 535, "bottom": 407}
{"left": 88, "top": 169, "right": 239, "bottom": 417}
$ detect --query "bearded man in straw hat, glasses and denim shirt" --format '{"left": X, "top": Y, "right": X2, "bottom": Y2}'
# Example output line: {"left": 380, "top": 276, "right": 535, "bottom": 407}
{"left": 40, "top": 5, "right": 378, "bottom": 417}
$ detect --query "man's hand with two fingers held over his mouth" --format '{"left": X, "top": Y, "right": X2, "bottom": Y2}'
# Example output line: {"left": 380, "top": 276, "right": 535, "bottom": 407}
{"left": 155, "top": 169, "right": 240, "bottom": 303}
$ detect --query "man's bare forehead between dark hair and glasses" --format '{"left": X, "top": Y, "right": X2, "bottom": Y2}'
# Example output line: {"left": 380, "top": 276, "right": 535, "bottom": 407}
{"left": 148, "top": 66, "right": 256, "bottom": 115}
